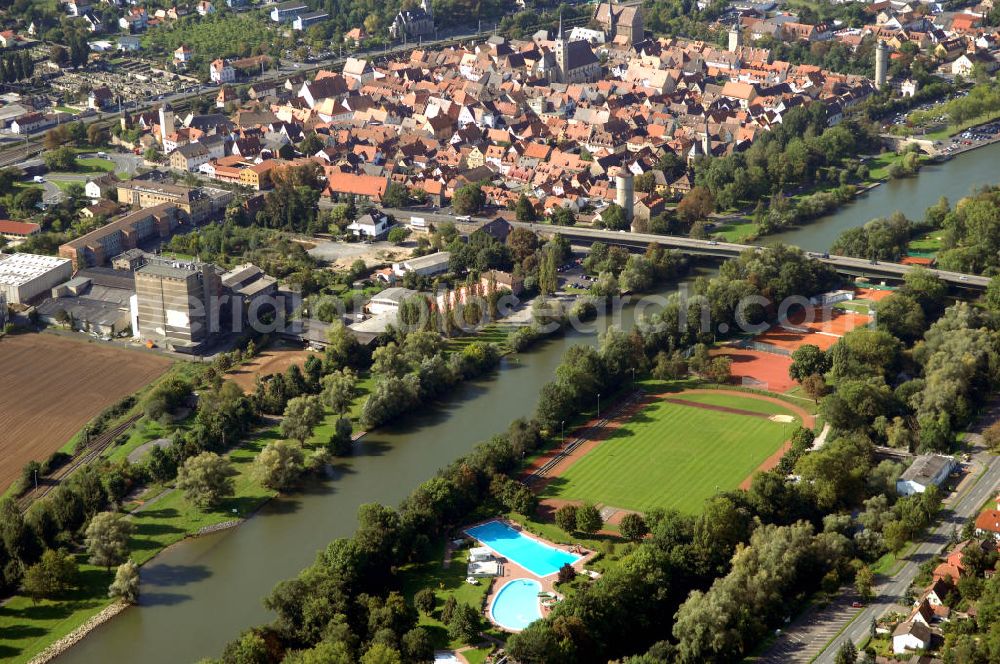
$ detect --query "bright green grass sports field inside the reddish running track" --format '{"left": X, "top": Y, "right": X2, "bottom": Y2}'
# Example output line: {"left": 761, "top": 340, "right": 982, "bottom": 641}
{"left": 543, "top": 393, "right": 800, "bottom": 514}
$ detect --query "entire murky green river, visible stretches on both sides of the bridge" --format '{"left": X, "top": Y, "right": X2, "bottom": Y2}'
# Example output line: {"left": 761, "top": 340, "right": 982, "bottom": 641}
{"left": 52, "top": 137, "right": 1000, "bottom": 664}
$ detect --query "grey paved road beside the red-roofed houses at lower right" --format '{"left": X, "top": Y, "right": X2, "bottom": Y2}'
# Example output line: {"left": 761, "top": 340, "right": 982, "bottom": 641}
{"left": 760, "top": 449, "right": 1000, "bottom": 664}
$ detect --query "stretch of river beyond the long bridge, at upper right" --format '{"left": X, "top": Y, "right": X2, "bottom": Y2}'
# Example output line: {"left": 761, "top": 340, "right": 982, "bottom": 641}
{"left": 761, "top": 143, "right": 1000, "bottom": 251}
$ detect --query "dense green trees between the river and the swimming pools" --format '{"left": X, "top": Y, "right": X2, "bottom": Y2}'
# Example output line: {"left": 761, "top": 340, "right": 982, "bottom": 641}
{"left": 223, "top": 421, "right": 541, "bottom": 663}
